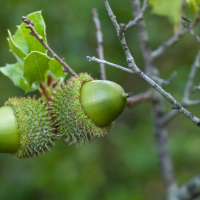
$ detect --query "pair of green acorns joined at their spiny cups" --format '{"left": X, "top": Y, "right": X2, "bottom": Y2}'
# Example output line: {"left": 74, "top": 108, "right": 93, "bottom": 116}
{"left": 0, "top": 73, "right": 127, "bottom": 158}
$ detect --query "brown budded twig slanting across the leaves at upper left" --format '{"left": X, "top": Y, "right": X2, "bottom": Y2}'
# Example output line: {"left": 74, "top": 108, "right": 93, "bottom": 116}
{"left": 22, "top": 16, "right": 77, "bottom": 76}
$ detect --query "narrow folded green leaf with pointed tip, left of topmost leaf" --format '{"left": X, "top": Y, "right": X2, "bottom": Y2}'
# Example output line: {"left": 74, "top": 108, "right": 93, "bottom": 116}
{"left": 8, "top": 30, "right": 27, "bottom": 65}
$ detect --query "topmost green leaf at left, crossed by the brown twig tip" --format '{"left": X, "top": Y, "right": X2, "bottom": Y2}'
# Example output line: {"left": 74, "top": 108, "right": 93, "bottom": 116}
{"left": 18, "top": 11, "right": 47, "bottom": 53}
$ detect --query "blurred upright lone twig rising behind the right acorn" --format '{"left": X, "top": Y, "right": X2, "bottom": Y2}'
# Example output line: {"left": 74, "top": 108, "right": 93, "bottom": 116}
{"left": 92, "top": 9, "right": 106, "bottom": 80}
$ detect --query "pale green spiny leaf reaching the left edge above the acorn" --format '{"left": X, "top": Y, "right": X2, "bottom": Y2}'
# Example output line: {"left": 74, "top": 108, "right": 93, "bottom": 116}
{"left": 0, "top": 63, "right": 38, "bottom": 92}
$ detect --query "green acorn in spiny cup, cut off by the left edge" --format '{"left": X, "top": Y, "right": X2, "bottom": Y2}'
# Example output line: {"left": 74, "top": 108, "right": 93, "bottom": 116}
{"left": 0, "top": 97, "right": 55, "bottom": 158}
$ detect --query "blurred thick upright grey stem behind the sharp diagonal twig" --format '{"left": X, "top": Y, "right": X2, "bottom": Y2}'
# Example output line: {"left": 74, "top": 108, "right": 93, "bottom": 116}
{"left": 131, "top": 0, "right": 177, "bottom": 197}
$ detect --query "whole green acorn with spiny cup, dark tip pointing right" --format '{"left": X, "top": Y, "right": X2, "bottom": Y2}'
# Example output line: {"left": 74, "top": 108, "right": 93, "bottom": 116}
{"left": 49, "top": 73, "right": 126, "bottom": 145}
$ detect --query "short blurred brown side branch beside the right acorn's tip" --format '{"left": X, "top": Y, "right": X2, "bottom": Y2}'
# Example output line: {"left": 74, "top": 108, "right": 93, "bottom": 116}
{"left": 127, "top": 91, "right": 153, "bottom": 108}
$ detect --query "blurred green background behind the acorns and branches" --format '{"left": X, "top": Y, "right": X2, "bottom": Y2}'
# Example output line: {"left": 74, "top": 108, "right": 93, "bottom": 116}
{"left": 0, "top": 0, "right": 200, "bottom": 200}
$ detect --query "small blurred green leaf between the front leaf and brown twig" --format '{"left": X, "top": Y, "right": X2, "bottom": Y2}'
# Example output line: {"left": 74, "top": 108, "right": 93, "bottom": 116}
{"left": 49, "top": 58, "right": 66, "bottom": 78}
